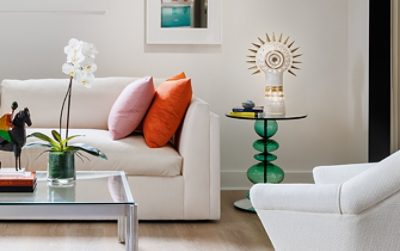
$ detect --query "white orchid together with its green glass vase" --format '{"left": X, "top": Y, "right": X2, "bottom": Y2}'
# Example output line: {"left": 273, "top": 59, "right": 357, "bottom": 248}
{"left": 27, "top": 39, "right": 107, "bottom": 185}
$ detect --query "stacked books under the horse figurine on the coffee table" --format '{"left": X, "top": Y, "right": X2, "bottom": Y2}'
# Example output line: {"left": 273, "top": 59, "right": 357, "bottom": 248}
{"left": 0, "top": 168, "right": 36, "bottom": 192}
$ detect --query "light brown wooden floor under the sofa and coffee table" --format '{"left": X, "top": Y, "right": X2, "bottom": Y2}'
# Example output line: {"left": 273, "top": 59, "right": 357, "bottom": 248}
{"left": 0, "top": 191, "right": 273, "bottom": 251}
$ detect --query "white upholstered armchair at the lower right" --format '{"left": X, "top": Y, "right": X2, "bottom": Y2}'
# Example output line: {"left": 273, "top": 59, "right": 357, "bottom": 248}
{"left": 250, "top": 151, "right": 400, "bottom": 251}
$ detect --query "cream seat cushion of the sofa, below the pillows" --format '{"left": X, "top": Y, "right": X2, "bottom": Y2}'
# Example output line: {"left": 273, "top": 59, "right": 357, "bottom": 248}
{"left": 22, "top": 128, "right": 182, "bottom": 177}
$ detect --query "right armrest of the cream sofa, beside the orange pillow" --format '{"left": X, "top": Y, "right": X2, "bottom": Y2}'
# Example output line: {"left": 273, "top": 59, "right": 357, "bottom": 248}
{"left": 177, "top": 98, "right": 220, "bottom": 219}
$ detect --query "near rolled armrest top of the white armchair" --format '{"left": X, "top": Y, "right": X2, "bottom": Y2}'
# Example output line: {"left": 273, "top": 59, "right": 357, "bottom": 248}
{"left": 250, "top": 184, "right": 340, "bottom": 214}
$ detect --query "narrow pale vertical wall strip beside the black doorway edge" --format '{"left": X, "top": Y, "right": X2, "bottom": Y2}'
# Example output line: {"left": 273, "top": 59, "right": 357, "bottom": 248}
{"left": 347, "top": 0, "right": 369, "bottom": 161}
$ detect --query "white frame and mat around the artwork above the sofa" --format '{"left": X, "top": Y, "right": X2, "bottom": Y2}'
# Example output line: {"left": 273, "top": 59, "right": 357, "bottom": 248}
{"left": 146, "top": 0, "right": 222, "bottom": 45}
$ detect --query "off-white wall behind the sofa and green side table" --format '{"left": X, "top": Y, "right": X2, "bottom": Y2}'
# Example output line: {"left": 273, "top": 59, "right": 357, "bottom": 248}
{"left": 0, "top": 0, "right": 368, "bottom": 188}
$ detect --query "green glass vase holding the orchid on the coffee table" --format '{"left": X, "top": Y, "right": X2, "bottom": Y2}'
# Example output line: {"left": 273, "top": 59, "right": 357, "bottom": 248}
{"left": 47, "top": 152, "right": 76, "bottom": 186}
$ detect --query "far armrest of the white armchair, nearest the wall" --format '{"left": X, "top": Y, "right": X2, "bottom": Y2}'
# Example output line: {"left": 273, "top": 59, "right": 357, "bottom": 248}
{"left": 313, "top": 163, "right": 376, "bottom": 184}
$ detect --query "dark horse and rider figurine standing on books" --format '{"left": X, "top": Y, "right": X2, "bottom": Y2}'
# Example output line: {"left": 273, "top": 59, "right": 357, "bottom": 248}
{"left": 0, "top": 101, "right": 32, "bottom": 172}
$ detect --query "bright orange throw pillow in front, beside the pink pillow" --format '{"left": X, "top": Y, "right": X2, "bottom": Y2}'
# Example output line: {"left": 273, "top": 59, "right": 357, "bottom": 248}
{"left": 143, "top": 73, "right": 192, "bottom": 148}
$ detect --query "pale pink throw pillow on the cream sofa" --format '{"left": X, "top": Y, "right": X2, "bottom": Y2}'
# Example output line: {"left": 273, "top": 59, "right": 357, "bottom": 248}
{"left": 108, "top": 77, "right": 155, "bottom": 140}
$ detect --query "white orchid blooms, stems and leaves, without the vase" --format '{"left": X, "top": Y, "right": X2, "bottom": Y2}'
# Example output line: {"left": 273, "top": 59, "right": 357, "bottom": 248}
{"left": 26, "top": 38, "right": 107, "bottom": 159}
